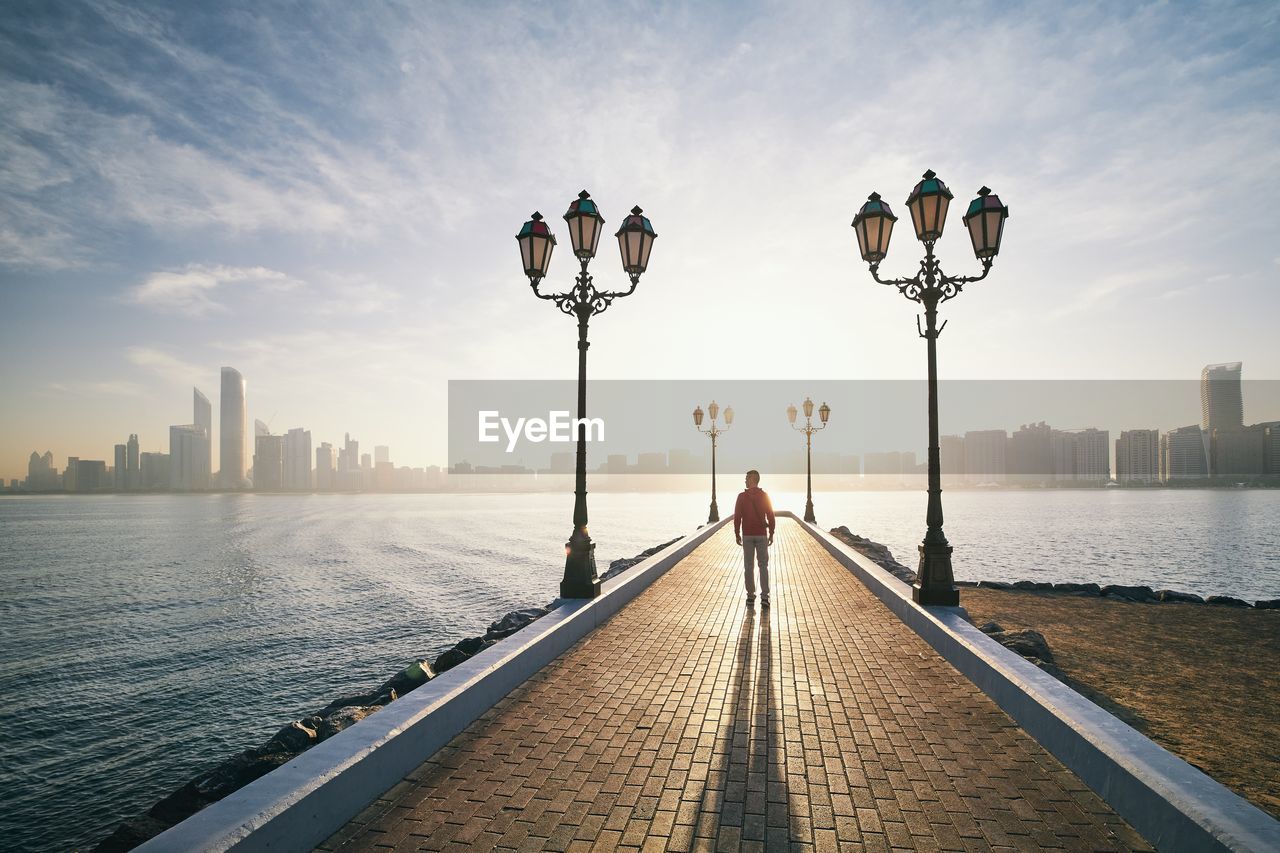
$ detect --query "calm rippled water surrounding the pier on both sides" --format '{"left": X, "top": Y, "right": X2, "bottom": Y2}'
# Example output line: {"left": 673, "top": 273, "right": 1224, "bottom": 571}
{"left": 0, "top": 483, "right": 1280, "bottom": 850}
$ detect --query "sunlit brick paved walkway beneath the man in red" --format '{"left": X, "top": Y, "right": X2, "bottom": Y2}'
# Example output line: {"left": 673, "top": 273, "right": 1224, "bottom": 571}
{"left": 321, "top": 519, "right": 1149, "bottom": 850}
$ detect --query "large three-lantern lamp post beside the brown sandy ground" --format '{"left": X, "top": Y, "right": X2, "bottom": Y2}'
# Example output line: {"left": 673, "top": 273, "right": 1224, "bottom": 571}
{"left": 852, "top": 170, "right": 1009, "bottom": 606}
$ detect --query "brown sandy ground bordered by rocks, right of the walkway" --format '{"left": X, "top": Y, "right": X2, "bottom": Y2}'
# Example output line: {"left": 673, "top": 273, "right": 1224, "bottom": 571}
{"left": 960, "top": 588, "right": 1280, "bottom": 817}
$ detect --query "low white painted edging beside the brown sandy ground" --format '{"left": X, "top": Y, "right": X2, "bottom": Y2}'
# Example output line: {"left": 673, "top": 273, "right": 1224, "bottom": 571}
{"left": 780, "top": 512, "right": 1280, "bottom": 853}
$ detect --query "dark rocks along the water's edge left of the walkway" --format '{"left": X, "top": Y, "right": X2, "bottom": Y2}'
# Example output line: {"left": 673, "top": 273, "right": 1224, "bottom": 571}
{"left": 95, "top": 537, "right": 680, "bottom": 853}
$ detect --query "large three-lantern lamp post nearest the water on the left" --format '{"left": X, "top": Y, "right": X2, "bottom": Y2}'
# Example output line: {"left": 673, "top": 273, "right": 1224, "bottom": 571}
{"left": 516, "top": 190, "right": 658, "bottom": 598}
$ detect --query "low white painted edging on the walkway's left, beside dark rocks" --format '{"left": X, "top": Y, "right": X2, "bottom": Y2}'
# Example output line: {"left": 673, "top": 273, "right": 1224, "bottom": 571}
{"left": 136, "top": 519, "right": 728, "bottom": 853}
